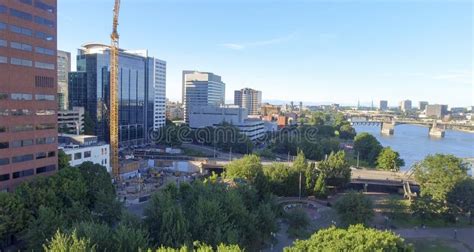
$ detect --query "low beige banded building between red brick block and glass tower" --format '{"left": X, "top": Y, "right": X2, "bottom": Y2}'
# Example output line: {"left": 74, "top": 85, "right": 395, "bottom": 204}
{"left": 58, "top": 107, "right": 84, "bottom": 135}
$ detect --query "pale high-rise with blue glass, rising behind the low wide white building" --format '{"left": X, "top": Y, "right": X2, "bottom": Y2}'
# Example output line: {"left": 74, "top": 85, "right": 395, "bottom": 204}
{"left": 182, "top": 71, "right": 225, "bottom": 123}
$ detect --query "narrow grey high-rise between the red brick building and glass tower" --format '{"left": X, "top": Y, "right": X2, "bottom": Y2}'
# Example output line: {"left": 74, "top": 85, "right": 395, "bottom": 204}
{"left": 57, "top": 50, "right": 71, "bottom": 110}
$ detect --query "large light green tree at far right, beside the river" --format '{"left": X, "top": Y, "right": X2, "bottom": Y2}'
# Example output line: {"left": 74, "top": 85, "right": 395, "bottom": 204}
{"left": 414, "top": 154, "right": 468, "bottom": 202}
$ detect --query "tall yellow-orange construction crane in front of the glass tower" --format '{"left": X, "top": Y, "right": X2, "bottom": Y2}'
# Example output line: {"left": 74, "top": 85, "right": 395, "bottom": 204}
{"left": 109, "top": 0, "right": 120, "bottom": 180}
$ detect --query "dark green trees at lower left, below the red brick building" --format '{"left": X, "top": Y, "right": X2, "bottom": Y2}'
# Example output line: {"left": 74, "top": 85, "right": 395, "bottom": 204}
{"left": 0, "top": 162, "right": 121, "bottom": 250}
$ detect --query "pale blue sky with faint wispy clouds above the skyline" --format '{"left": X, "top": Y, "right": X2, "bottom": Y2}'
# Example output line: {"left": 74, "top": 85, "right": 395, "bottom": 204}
{"left": 58, "top": 0, "right": 474, "bottom": 106}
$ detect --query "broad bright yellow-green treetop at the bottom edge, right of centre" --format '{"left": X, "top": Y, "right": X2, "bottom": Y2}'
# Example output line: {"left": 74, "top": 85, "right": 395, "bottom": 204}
{"left": 284, "top": 225, "right": 413, "bottom": 252}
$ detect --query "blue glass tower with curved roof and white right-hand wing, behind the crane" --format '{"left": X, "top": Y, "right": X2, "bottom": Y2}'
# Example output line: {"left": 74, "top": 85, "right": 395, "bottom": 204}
{"left": 69, "top": 44, "right": 166, "bottom": 146}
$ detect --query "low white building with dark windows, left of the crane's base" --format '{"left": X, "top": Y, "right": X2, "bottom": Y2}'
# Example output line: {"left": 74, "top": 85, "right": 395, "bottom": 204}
{"left": 59, "top": 134, "right": 112, "bottom": 173}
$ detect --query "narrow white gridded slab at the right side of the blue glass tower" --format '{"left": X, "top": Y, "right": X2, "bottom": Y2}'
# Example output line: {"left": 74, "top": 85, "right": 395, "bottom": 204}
{"left": 153, "top": 58, "right": 166, "bottom": 130}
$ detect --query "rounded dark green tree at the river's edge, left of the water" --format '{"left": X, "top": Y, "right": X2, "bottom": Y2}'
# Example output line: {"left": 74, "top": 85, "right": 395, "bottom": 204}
{"left": 354, "top": 132, "right": 382, "bottom": 165}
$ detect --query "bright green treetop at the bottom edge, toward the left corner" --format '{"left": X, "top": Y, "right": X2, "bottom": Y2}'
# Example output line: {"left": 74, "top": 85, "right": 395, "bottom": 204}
{"left": 43, "top": 230, "right": 96, "bottom": 252}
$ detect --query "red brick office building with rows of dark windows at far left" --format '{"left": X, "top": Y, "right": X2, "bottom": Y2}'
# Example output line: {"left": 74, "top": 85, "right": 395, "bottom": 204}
{"left": 0, "top": 0, "right": 58, "bottom": 191}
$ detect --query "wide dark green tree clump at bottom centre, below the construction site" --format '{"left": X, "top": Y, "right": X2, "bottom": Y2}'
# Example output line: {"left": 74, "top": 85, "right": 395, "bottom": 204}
{"left": 145, "top": 181, "right": 277, "bottom": 249}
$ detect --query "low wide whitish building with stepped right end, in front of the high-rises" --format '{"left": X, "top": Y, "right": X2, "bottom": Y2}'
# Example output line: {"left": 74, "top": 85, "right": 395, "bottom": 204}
{"left": 189, "top": 105, "right": 266, "bottom": 141}
